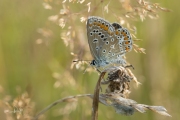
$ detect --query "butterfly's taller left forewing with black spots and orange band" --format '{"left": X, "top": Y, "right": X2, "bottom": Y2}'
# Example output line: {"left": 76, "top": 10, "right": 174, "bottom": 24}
{"left": 87, "top": 17, "right": 114, "bottom": 61}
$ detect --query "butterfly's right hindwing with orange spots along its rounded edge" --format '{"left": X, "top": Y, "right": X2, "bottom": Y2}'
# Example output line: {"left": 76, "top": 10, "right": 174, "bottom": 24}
{"left": 100, "top": 23, "right": 132, "bottom": 64}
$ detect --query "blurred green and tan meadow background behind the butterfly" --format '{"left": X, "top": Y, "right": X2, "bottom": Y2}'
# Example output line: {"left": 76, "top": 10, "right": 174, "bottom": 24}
{"left": 0, "top": 0, "right": 180, "bottom": 120}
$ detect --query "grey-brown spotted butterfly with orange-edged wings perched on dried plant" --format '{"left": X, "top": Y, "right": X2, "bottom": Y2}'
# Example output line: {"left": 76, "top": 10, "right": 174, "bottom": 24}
{"left": 87, "top": 16, "right": 133, "bottom": 68}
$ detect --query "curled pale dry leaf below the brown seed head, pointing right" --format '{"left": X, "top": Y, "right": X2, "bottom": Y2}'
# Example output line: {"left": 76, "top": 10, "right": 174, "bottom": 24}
{"left": 99, "top": 93, "right": 171, "bottom": 117}
